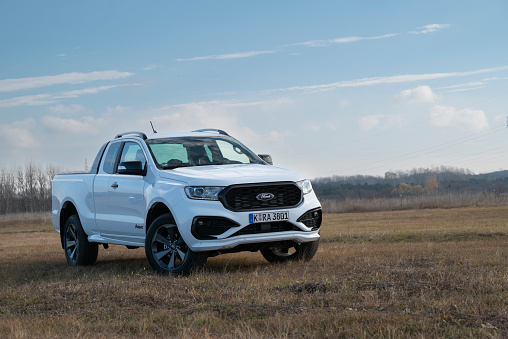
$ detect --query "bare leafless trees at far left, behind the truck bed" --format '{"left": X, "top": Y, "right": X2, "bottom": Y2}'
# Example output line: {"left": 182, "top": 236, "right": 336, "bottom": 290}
{"left": 0, "top": 162, "right": 59, "bottom": 215}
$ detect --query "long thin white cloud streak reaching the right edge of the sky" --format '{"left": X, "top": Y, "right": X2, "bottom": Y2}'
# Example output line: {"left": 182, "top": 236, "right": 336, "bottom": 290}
{"left": 272, "top": 66, "right": 508, "bottom": 91}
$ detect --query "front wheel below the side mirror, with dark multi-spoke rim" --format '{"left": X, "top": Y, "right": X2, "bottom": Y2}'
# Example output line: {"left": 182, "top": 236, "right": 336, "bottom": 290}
{"left": 145, "top": 214, "right": 208, "bottom": 275}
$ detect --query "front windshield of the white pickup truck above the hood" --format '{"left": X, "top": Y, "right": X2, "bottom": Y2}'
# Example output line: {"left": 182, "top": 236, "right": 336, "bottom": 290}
{"left": 146, "top": 137, "right": 262, "bottom": 169}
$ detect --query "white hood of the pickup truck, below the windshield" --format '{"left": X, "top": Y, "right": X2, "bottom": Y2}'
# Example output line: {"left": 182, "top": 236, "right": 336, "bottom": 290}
{"left": 160, "top": 164, "right": 305, "bottom": 186}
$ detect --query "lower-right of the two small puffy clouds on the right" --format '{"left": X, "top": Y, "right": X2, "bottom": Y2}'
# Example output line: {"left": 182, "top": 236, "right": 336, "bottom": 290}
{"left": 429, "top": 105, "right": 489, "bottom": 131}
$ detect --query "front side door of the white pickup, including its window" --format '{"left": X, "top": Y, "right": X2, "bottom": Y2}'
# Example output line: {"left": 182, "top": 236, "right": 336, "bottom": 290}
{"left": 101, "top": 141, "right": 146, "bottom": 242}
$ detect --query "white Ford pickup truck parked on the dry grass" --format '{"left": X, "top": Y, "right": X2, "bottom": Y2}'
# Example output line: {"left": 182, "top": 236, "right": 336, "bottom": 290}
{"left": 52, "top": 129, "right": 322, "bottom": 275}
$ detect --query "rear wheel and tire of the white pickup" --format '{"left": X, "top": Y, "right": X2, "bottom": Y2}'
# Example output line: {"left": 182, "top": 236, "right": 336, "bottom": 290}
{"left": 63, "top": 214, "right": 99, "bottom": 266}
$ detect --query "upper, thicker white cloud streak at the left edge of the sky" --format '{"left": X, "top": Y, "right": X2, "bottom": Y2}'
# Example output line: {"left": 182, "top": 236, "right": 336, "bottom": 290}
{"left": 0, "top": 71, "right": 134, "bottom": 92}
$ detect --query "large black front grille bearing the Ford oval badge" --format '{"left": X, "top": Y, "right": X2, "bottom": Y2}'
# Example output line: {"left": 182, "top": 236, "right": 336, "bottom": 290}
{"left": 220, "top": 183, "right": 302, "bottom": 211}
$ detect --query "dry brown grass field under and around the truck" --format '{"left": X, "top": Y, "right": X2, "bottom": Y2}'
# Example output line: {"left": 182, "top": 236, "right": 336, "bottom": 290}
{"left": 0, "top": 207, "right": 508, "bottom": 338}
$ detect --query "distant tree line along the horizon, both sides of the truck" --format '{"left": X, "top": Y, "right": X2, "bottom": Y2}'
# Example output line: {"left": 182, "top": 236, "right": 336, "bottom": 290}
{"left": 0, "top": 162, "right": 508, "bottom": 215}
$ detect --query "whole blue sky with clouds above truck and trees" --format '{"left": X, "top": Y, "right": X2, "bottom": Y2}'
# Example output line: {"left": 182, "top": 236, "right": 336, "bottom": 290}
{"left": 0, "top": 1, "right": 508, "bottom": 178}
